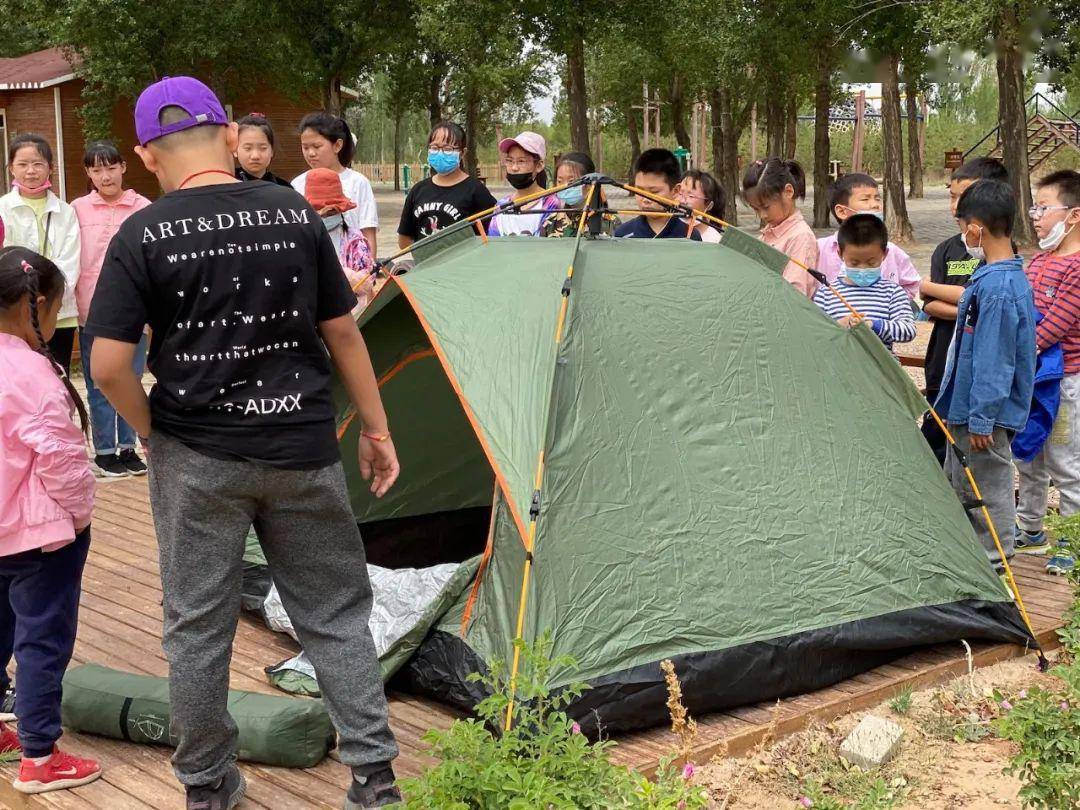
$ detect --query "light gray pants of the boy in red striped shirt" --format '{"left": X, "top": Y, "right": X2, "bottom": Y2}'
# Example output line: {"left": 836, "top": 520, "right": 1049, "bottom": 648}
{"left": 1016, "top": 374, "right": 1080, "bottom": 531}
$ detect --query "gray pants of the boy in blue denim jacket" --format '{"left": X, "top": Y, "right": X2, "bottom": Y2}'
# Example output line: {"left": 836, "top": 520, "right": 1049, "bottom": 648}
{"left": 945, "top": 422, "right": 1016, "bottom": 565}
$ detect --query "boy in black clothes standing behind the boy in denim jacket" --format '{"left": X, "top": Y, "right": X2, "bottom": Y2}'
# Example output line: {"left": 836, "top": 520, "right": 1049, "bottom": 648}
{"left": 919, "top": 158, "right": 1009, "bottom": 464}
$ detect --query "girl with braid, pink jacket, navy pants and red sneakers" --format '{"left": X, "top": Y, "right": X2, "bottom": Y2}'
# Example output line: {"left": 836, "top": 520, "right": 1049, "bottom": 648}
{"left": 0, "top": 247, "right": 102, "bottom": 793}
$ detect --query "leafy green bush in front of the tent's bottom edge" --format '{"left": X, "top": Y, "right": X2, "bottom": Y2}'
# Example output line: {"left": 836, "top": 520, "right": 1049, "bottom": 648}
{"left": 402, "top": 635, "right": 706, "bottom": 810}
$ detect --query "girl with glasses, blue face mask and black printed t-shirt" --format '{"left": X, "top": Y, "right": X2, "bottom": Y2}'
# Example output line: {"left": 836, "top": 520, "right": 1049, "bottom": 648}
{"left": 397, "top": 121, "right": 495, "bottom": 249}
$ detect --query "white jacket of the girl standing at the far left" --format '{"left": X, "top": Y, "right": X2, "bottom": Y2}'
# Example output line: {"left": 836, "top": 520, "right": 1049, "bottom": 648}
{"left": 0, "top": 189, "right": 79, "bottom": 321}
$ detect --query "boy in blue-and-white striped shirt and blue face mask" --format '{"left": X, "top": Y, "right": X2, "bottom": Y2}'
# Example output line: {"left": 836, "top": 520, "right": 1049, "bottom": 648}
{"left": 813, "top": 214, "right": 915, "bottom": 351}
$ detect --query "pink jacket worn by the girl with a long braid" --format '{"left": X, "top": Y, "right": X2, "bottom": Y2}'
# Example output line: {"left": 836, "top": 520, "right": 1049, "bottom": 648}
{"left": 0, "top": 333, "right": 94, "bottom": 556}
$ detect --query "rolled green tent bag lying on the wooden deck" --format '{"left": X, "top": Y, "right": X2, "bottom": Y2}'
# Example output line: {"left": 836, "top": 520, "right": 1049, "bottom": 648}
{"left": 63, "top": 664, "right": 335, "bottom": 768}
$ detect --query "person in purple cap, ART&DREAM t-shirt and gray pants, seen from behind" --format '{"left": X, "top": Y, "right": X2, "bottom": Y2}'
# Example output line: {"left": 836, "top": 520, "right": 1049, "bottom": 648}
{"left": 86, "top": 77, "right": 400, "bottom": 810}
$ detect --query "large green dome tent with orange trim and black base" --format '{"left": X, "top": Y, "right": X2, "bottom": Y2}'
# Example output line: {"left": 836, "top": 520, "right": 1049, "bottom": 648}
{"left": 338, "top": 228, "right": 1029, "bottom": 731}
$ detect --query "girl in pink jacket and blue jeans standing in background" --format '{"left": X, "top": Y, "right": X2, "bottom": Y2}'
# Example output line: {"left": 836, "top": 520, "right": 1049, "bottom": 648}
{"left": 71, "top": 140, "right": 150, "bottom": 478}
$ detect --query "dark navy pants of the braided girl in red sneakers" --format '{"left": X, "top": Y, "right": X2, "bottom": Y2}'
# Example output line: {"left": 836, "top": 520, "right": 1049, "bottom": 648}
{"left": 0, "top": 526, "right": 90, "bottom": 757}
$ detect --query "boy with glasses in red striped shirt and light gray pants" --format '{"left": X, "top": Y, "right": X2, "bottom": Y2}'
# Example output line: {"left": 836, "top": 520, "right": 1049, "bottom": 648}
{"left": 1016, "top": 170, "right": 1080, "bottom": 573}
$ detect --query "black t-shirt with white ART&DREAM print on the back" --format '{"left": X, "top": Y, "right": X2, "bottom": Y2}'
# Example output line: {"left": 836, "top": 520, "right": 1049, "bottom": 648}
{"left": 86, "top": 177, "right": 356, "bottom": 470}
